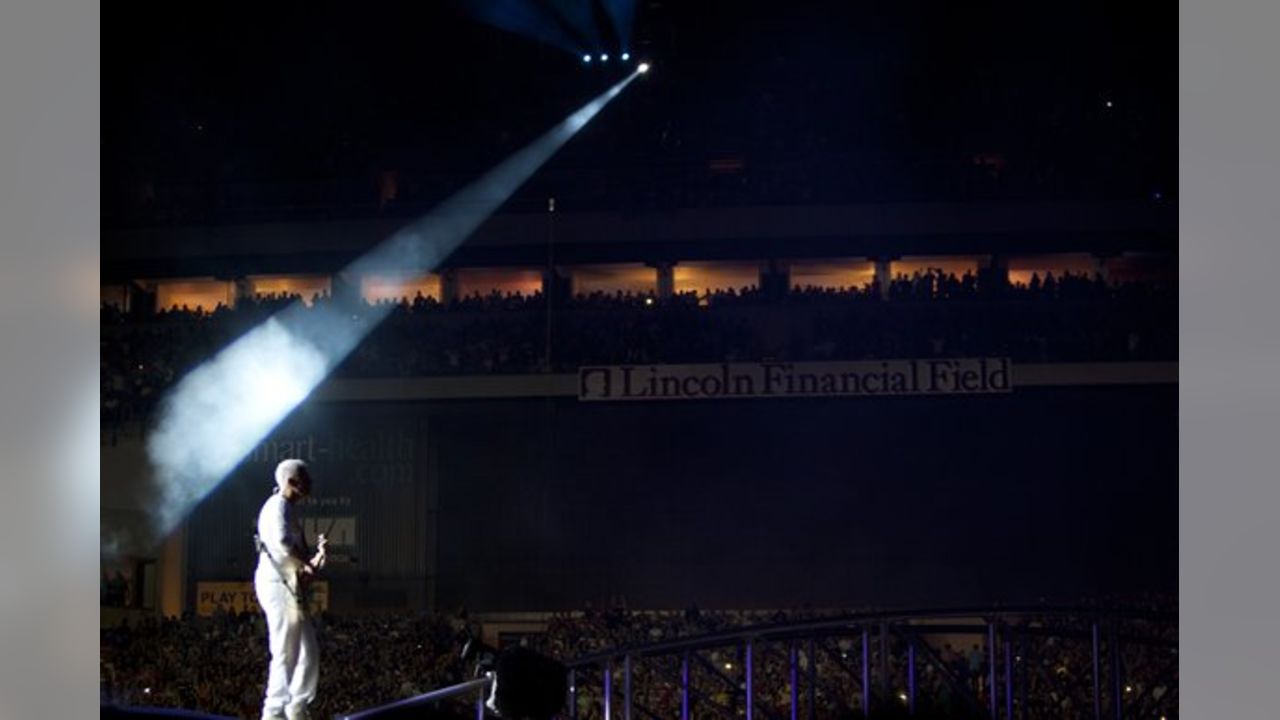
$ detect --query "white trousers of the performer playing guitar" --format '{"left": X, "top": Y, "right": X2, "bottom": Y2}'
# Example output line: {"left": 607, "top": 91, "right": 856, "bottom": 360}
{"left": 253, "top": 570, "right": 320, "bottom": 717}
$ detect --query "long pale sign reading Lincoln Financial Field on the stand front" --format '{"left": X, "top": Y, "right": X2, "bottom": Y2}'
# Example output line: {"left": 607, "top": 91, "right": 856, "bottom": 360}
{"left": 577, "top": 357, "right": 1012, "bottom": 401}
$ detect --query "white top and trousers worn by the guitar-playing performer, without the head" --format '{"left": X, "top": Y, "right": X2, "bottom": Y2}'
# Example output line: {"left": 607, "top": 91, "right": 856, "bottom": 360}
{"left": 253, "top": 492, "right": 320, "bottom": 720}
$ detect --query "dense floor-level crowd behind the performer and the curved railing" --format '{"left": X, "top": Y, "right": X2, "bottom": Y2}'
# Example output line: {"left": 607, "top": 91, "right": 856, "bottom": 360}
{"left": 100, "top": 601, "right": 1178, "bottom": 719}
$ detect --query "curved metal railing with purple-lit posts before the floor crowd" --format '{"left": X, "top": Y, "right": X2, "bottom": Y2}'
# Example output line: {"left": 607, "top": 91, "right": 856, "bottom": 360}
{"left": 567, "top": 606, "right": 1178, "bottom": 720}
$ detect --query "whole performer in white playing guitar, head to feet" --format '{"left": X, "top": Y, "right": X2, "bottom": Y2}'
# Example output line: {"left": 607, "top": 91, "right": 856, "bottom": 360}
{"left": 253, "top": 460, "right": 325, "bottom": 720}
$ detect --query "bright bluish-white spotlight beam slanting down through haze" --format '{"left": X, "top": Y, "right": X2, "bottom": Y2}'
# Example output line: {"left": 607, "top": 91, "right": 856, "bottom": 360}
{"left": 147, "top": 73, "right": 637, "bottom": 537}
